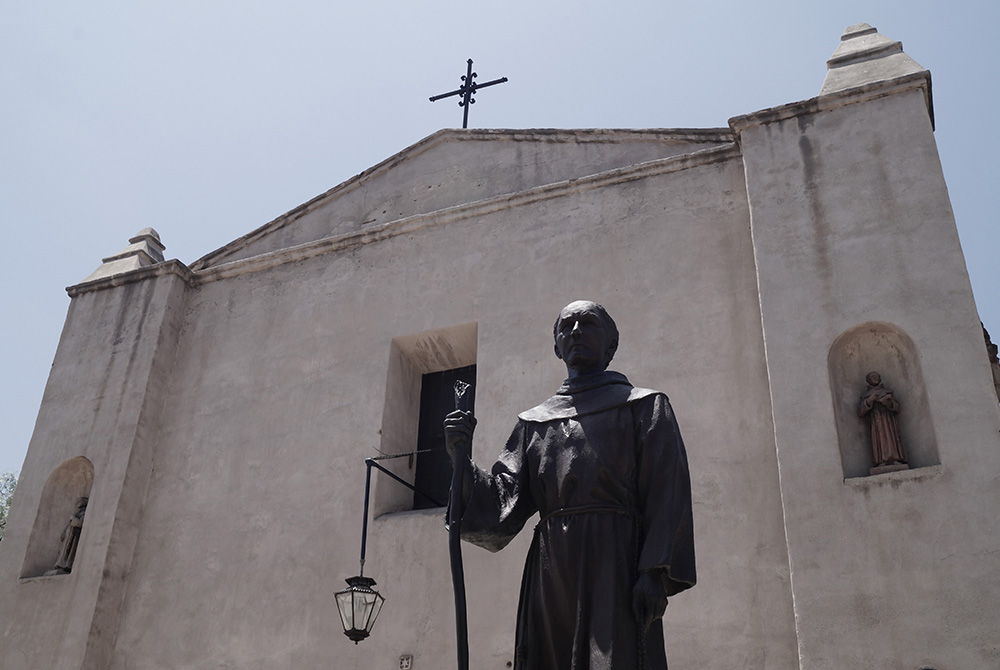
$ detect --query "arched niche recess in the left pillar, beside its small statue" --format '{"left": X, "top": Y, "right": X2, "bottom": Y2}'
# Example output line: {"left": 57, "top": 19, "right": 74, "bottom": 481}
{"left": 21, "top": 456, "right": 94, "bottom": 579}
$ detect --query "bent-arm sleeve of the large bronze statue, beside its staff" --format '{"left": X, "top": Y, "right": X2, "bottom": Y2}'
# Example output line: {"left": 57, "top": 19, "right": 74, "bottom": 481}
{"left": 462, "top": 421, "right": 537, "bottom": 551}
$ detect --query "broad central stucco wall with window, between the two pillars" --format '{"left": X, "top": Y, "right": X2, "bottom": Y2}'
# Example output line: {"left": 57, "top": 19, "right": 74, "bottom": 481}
{"left": 95, "top": 146, "right": 795, "bottom": 669}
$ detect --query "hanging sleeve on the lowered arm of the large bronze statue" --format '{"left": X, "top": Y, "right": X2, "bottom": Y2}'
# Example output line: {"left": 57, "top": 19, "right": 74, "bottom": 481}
{"left": 634, "top": 393, "right": 696, "bottom": 596}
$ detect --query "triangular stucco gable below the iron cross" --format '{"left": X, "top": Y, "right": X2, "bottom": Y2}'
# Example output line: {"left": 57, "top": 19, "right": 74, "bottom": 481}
{"left": 192, "top": 129, "right": 732, "bottom": 270}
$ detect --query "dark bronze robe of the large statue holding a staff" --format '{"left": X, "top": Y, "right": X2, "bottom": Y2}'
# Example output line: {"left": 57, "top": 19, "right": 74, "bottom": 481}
{"left": 462, "top": 372, "right": 695, "bottom": 670}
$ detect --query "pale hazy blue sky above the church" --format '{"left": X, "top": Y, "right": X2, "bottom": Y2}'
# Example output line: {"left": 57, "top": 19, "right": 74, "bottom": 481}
{"left": 0, "top": 0, "right": 1000, "bottom": 472}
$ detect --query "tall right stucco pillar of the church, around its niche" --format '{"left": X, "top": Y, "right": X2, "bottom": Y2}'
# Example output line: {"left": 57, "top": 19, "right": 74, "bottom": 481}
{"left": 733, "top": 75, "right": 1000, "bottom": 670}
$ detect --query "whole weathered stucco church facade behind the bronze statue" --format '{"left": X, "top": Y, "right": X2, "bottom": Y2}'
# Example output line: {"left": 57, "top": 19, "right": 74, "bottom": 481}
{"left": 0, "top": 24, "right": 1000, "bottom": 670}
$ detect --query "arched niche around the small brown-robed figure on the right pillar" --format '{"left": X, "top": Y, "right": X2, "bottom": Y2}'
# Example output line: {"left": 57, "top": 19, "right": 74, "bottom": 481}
{"left": 828, "top": 321, "right": 941, "bottom": 478}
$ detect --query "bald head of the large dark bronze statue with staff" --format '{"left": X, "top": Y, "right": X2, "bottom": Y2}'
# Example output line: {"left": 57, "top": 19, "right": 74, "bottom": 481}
{"left": 555, "top": 301, "right": 618, "bottom": 375}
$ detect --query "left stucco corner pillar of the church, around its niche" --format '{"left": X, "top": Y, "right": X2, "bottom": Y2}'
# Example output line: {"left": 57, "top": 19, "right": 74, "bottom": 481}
{"left": 0, "top": 266, "right": 183, "bottom": 670}
